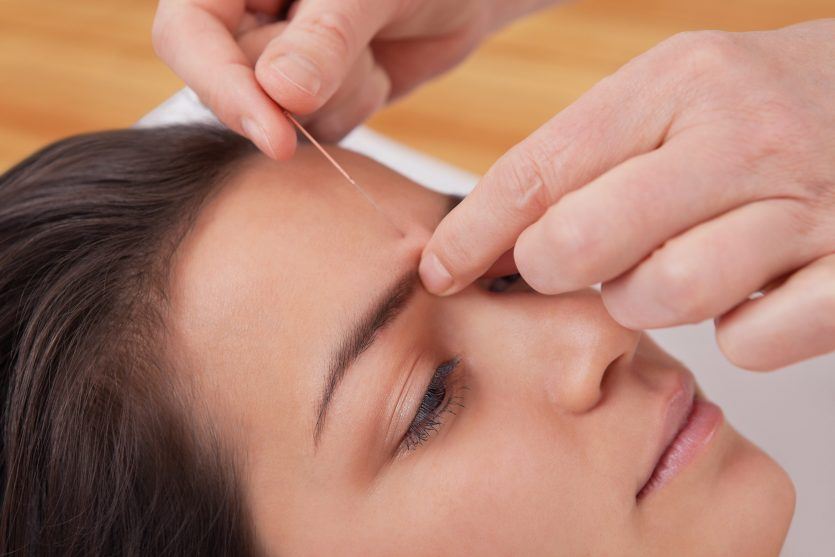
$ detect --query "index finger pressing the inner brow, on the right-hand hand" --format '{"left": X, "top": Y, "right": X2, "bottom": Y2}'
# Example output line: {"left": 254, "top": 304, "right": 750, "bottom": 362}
{"left": 420, "top": 59, "right": 684, "bottom": 295}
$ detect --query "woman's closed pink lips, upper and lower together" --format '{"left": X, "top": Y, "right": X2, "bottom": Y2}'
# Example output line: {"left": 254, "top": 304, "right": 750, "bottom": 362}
{"left": 637, "top": 373, "right": 723, "bottom": 499}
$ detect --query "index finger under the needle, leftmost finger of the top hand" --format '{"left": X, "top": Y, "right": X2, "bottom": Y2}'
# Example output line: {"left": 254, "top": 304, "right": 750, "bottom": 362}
{"left": 153, "top": 0, "right": 296, "bottom": 159}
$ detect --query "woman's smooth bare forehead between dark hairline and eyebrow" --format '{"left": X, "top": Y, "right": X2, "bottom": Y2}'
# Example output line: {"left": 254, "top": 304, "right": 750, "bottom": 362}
{"left": 170, "top": 149, "right": 447, "bottom": 450}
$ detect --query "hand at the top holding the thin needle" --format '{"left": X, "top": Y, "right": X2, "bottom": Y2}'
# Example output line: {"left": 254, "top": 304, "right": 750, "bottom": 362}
{"left": 153, "top": 0, "right": 553, "bottom": 158}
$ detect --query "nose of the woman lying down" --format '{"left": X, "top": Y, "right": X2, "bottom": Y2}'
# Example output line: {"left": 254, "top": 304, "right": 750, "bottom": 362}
{"left": 453, "top": 290, "right": 640, "bottom": 413}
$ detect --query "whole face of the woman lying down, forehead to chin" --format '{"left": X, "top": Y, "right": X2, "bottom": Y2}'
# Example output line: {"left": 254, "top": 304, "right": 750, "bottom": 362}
{"left": 171, "top": 147, "right": 794, "bottom": 556}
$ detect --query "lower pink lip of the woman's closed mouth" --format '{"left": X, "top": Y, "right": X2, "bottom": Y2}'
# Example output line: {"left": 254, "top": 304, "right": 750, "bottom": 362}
{"left": 638, "top": 396, "right": 723, "bottom": 499}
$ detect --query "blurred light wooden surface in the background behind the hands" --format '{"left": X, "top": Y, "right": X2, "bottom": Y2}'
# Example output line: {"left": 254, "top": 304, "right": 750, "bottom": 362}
{"left": 0, "top": 0, "right": 835, "bottom": 172}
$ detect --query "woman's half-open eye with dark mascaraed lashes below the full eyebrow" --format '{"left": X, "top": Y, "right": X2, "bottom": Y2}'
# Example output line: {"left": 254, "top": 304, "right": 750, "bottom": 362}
{"left": 400, "top": 358, "right": 467, "bottom": 452}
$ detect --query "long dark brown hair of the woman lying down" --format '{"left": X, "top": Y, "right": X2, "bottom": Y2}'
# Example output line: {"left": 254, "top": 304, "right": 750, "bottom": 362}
{"left": 0, "top": 125, "right": 264, "bottom": 557}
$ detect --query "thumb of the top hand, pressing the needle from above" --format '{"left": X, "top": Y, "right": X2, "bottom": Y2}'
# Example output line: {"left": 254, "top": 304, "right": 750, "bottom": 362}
{"left": 255, "top": 0, "right": 396, "bottom": 114}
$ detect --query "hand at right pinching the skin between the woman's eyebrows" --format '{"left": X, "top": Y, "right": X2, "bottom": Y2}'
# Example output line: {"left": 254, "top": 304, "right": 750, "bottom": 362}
{"left": 420, "top": 20, "right": 835, "bottom": 369}
